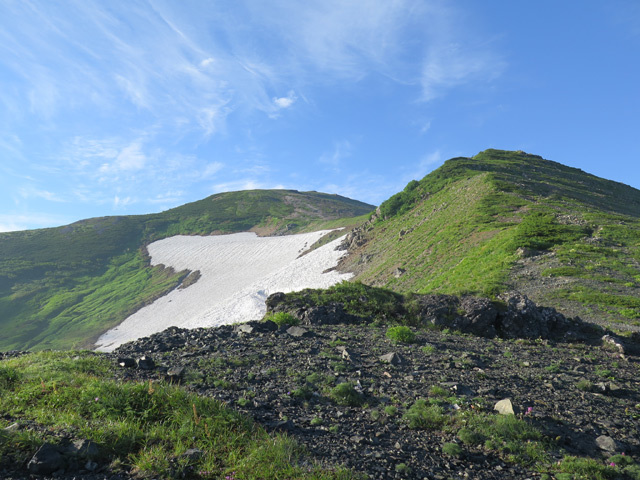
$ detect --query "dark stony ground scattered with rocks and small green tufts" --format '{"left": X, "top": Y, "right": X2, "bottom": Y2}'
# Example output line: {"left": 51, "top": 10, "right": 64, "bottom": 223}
{"left": 1, "top": 292, "right": 640, "bottom": 480}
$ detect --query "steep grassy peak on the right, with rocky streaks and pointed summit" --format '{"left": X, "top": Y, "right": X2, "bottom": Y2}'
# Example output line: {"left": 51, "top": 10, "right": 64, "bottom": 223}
{"left": 341, "top": 150, "right": 640, "bottom": 325}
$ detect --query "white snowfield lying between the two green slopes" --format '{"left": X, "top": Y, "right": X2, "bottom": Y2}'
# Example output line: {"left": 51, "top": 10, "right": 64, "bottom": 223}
{"left": 96, "top": 230, "right": 352, "bottom": 352}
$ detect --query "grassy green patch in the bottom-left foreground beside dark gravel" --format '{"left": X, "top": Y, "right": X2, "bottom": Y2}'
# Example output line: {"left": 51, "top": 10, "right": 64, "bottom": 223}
{"left": 0, "top": 352, "right": 355, "bottom": 479}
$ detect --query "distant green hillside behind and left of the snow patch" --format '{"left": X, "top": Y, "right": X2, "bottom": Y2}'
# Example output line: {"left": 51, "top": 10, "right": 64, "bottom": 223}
{"left": 0, "top": 190, "right": 373, "bottom": 350}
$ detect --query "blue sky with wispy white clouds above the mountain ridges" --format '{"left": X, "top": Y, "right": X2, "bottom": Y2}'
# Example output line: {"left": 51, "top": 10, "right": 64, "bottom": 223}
{"left": 0, "top": 0, "right": 640, "bottom": 231}
